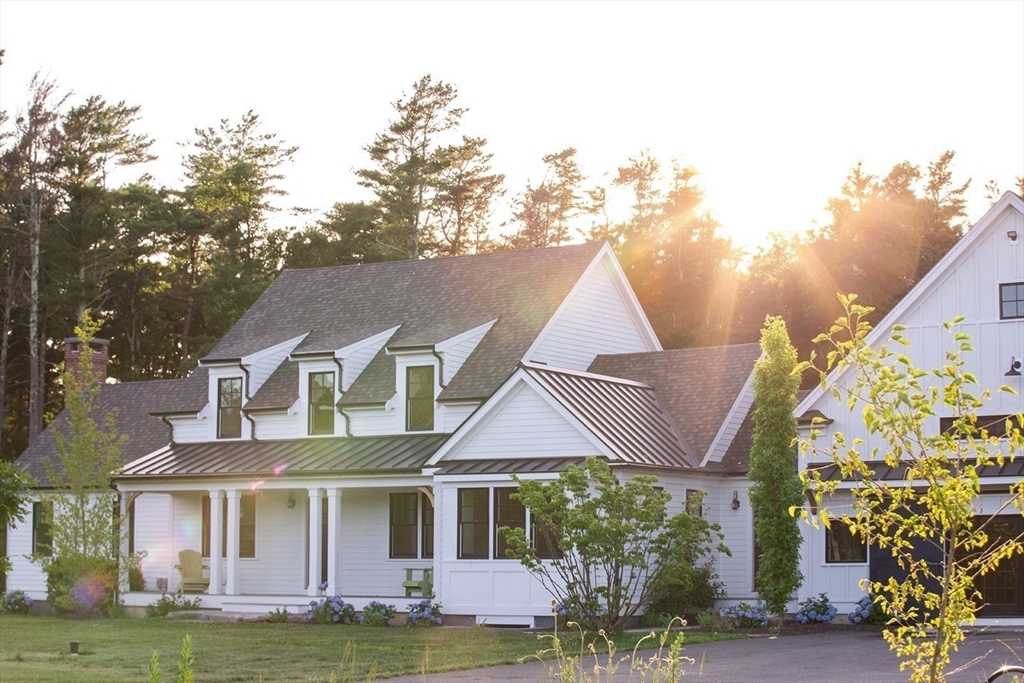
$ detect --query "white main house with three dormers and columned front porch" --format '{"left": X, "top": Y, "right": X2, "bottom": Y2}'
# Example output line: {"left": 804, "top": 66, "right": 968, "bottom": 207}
{"left": 8, "top": 244, "right": 760, "bottom": 625}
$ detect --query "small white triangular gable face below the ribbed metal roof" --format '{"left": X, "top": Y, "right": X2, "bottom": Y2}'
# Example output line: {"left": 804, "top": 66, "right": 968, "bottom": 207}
{"left": 449, "top": 384, "right": 598, "bottom": 460}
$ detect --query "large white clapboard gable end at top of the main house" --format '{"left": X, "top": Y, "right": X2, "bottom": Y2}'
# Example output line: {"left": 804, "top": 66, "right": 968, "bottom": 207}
{"left": 523, "top": 254, "right": 655, "bottom": 371}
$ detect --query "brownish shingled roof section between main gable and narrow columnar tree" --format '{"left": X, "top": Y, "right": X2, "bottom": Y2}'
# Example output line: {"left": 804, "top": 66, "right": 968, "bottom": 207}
{"left": 590, "top": 344, "right": 761, "bottom": 471}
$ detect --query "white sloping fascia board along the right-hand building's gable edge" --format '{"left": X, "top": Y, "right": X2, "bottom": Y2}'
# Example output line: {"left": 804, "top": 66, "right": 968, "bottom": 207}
{"left": 794, "top": 191, "right": 1024, "bottom": 417}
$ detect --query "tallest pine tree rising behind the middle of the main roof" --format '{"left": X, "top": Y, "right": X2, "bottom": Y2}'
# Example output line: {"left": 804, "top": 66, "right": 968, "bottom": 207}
{"left": 356, "top": 74, "right": 466, "bottom": 259}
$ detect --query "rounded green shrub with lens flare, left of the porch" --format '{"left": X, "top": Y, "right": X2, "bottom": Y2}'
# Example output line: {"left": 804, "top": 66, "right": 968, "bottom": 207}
{"left": 45, "top": 557, "right": 118, "bottom": 615}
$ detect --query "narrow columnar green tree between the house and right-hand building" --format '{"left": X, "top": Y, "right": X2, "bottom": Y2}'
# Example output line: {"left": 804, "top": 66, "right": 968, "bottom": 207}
{"left": 748, "top": 317, "right": 804, "bottom": 625}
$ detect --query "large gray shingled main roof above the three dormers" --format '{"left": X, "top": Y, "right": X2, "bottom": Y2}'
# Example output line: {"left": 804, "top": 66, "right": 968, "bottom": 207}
{"left": 205, "top": 243, "right": 601, "bottom": 404}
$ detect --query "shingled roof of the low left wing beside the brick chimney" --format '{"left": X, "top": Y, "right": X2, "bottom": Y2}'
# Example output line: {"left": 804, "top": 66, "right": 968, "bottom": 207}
{"left": 15, "top": 372, "right": 207, "bottom": 487}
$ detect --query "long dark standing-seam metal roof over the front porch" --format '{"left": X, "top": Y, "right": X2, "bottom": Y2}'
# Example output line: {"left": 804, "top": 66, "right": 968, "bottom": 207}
{"left": 118, "top": 434, "right": 449, "bottom": 478}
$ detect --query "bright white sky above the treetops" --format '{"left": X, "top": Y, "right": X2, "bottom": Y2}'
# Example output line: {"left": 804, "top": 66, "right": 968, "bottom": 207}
{"left": 0, "top": 0, "right": 1024, "bottom": 253}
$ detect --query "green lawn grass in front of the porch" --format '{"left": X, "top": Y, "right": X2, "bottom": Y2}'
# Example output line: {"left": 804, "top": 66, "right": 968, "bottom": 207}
{"left": 0, "top": 613, "right": 734, "bottom": 683}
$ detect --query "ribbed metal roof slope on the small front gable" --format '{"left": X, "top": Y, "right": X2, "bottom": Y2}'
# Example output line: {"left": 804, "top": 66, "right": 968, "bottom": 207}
{"left": 522, "top": 364, "right": 698, "bottom": 467}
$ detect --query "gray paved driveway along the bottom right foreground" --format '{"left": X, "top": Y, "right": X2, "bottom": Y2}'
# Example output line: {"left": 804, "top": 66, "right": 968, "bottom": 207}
{"left": 388, "top": 631, "right": 1024, "bottom": 683}
